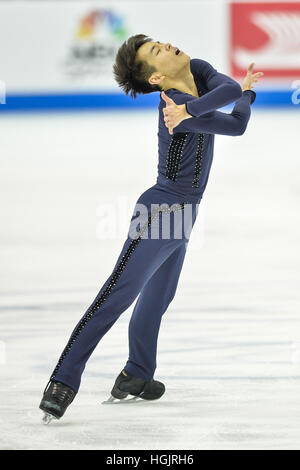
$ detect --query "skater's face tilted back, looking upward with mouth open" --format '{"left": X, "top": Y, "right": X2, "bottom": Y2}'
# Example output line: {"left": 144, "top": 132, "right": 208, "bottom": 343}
{"left": 136, "top": 41, "right": 190, "bottom": 85}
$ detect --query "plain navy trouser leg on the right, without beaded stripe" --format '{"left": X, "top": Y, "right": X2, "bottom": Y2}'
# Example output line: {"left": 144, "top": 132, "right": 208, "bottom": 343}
{"left": 125, "top": 242, "right": 186, "bottom": 380}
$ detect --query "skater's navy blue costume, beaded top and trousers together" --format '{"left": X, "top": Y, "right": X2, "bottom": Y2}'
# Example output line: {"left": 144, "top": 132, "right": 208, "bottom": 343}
{"left": 50, "top": 58, "right": 256, "bottom": 392}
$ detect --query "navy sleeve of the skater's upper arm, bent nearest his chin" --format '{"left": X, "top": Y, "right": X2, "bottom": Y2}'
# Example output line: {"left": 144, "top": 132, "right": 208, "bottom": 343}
{"left": 185, "top": 59, "right": 242, "bottom": 117}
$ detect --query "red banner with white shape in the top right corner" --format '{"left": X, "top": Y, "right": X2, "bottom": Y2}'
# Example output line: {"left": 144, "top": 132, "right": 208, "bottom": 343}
{"left": 230, "top": 2, "right": 300, "bottom": 78}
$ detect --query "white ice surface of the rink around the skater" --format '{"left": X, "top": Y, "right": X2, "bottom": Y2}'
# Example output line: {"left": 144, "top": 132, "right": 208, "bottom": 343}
{"left": 0, "top": 106, "right": 300, "bottom": 450}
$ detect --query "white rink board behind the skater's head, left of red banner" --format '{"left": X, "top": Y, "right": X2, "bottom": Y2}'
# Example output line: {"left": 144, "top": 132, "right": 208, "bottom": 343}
{"left": 0, "top": 0, "right": 227, "bottom": 93}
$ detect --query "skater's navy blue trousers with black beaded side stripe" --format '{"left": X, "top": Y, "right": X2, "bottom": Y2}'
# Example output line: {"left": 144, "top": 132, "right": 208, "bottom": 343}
{"left": 51, "top": 184, "right": 200, "bottom": 392}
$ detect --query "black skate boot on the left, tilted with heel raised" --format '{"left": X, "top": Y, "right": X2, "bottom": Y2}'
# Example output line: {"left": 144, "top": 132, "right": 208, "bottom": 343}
{"left": 39, "top": 381, "right": 76, "bottom": 424}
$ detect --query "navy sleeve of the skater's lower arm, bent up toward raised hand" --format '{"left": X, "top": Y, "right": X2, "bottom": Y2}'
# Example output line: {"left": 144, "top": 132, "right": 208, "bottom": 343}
{"left": 174, "top": 90, "right": 256, "bottom": 136}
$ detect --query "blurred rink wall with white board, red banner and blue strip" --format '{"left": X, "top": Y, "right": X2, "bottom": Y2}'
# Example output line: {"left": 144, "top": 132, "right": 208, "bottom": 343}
{"left": 0, "top": 0, "right": 300, "bottom": 112}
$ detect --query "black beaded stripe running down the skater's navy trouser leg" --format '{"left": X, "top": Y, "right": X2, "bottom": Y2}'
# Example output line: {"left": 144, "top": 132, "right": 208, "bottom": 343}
{"left": 50, "top": 201, "right": 187, "bottom": 380}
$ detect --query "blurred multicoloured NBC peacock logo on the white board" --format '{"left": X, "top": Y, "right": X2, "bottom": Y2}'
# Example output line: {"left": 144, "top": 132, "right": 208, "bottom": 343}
{"left": 64, "top": 9, "right": 128, "bottom": 78}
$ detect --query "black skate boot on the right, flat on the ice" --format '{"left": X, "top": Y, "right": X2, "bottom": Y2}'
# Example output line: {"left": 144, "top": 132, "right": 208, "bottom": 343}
{"left": 103, "top": 369, "right": 165, "bottom": 404}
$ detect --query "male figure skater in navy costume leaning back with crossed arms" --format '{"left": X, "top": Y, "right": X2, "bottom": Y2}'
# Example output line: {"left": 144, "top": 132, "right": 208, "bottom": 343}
{"left": 40, "top": 34, "right": 263, "bottom": 423}
